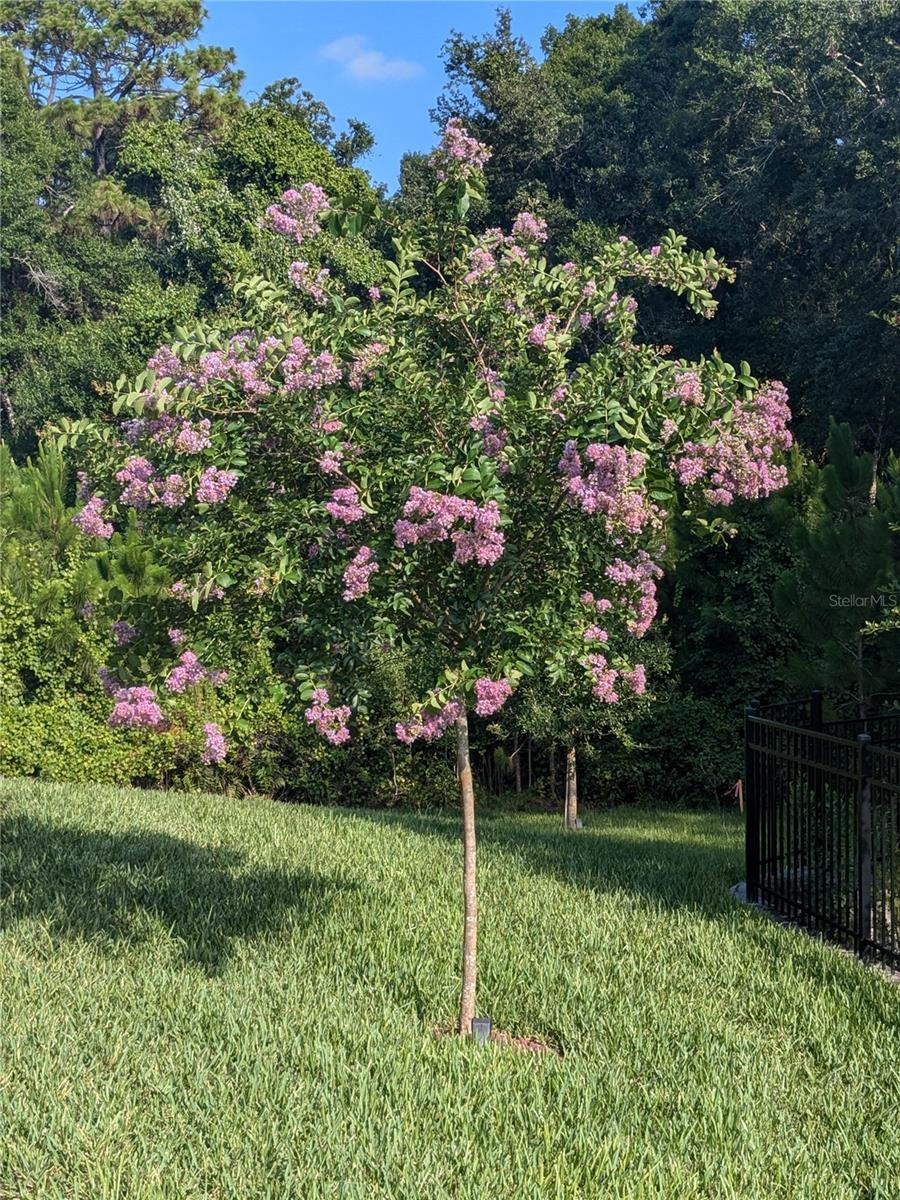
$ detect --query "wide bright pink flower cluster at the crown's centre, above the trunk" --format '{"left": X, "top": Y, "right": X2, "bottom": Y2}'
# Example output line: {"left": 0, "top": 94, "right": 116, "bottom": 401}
{"left": 394, "top": 487, "right": 505, "bottom": 566}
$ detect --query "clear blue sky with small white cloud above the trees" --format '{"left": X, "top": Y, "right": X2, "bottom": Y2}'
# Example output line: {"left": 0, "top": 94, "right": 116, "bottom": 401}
{"left": 200, "top": 0, "right": 643, "bottom": 190}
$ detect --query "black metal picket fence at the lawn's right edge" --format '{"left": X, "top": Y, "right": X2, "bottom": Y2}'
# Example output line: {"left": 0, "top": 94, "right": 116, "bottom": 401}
{"left": 744, "top": 692, "right": 900, "bottom": 970}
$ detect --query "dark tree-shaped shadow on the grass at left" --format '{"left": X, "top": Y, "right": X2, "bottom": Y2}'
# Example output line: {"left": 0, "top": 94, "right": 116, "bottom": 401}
{"left": 2, "top": 817, "right": 349, "bottom": 976}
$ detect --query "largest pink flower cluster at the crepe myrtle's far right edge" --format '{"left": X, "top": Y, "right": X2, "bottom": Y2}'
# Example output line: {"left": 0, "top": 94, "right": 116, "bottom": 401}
{"left": 674, "top": 382, "right": 793, "bottom": 505}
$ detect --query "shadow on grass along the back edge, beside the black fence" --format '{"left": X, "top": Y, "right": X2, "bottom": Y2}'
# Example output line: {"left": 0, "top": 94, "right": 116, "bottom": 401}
{"left": 336, "top": 809, "right": 743, "bottom": 917}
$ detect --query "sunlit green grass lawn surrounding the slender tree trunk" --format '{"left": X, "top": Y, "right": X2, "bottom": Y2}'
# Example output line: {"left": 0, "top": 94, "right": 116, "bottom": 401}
{"left": 0, "top": 781, "right": 900, "bottom": 1200}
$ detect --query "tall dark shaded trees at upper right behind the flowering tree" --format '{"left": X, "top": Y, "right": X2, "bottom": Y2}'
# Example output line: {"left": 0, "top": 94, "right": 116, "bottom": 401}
{"left": 424, "top": 0, "right": 900, "bottom": 454}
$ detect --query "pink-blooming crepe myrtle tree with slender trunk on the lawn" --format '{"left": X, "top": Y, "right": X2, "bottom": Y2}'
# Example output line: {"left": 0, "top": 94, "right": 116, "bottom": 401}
{"left": 62, "top": 121, "right": 790, "bottom": 1033}
